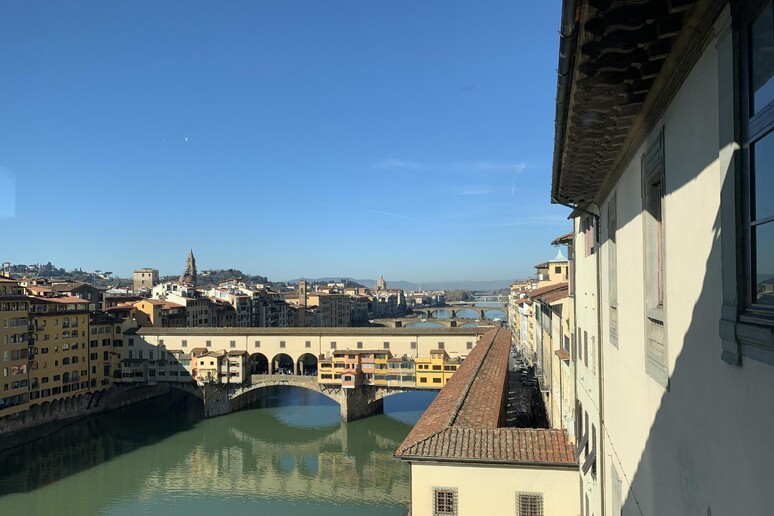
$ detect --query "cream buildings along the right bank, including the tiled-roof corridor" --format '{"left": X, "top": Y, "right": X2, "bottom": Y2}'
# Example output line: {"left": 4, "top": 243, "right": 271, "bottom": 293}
{"left": 397, "top": 0, "right": 774, "bottom": 516}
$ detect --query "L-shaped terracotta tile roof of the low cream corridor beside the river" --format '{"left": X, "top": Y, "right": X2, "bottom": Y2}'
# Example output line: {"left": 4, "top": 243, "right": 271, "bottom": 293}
{"left": 395, "top": 328, "right": 577, "bottom": 467}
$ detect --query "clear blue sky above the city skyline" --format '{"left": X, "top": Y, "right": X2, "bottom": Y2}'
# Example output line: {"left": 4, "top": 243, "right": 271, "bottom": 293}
{"left": 0, "top": 0, "right": 570, "bottom": 282}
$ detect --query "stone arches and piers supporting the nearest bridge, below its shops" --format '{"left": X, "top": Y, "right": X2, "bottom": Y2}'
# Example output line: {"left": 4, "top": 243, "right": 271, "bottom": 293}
{"left": 202, "top": 374, "right": 433, "bottom": 422}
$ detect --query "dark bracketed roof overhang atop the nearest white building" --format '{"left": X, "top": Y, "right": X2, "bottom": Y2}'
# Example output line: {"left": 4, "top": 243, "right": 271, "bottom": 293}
{"left": 551, "top": 0, "right": 727, "bottom": 206}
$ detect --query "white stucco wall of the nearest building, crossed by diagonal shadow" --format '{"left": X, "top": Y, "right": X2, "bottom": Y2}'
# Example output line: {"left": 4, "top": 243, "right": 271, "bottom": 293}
{"left": 596, "top": 14, "right": 774, "bottom": 516}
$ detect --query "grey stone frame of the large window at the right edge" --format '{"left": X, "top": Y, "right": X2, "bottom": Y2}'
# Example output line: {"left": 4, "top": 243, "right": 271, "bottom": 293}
{"left": 714, "top": 5, "right": 774, "bottom": 366}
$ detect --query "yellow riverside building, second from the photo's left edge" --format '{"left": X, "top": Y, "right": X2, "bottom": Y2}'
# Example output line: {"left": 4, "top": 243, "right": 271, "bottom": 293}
{"left": 29, "top": 297, "right": 95, "bottom": 403}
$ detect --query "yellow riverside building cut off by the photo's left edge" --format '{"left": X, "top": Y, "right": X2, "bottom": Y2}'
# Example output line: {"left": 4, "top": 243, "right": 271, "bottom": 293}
{"left": 0, "top": 276, "right": 30, "bottom": 416}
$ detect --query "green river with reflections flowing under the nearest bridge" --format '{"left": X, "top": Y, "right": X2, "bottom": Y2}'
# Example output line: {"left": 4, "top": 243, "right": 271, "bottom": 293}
{"left": 0, "top": 387, "right": 435, "bottom": 516}
